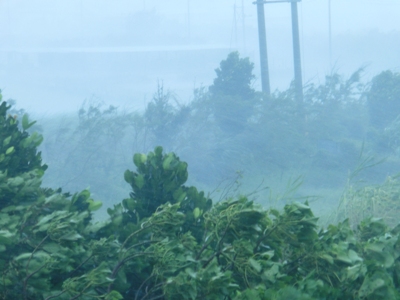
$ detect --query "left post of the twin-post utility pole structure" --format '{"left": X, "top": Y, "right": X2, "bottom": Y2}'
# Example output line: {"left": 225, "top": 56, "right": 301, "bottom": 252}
{"left": 253, "top": 0, "right": 271, "bottom": 96}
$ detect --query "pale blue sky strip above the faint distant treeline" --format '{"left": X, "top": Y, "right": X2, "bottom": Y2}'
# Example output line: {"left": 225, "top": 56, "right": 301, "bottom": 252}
{"left": 0, "top": 0, "right": 400, "bottom": 42}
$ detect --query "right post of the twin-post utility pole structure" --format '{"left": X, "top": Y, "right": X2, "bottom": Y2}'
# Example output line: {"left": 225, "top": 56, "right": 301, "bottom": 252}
{"left": 290, "top": 0, "right": 303, "bottom": 103}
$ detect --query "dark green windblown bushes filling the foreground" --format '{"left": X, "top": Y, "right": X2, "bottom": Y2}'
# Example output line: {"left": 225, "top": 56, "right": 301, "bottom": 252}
{"left": 0, "top": 96, "right": 400, "bottom": 300}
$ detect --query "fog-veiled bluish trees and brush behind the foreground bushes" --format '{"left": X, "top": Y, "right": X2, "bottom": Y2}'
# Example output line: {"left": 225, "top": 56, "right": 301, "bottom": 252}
{"left": 33, "top": 53, "right": 400, "bottom": 211}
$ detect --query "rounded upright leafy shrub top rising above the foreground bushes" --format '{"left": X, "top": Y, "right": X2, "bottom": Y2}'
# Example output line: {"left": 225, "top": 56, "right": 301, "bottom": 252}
{"left": 119, "top": 147, "right": 211, "bottom": 238}
